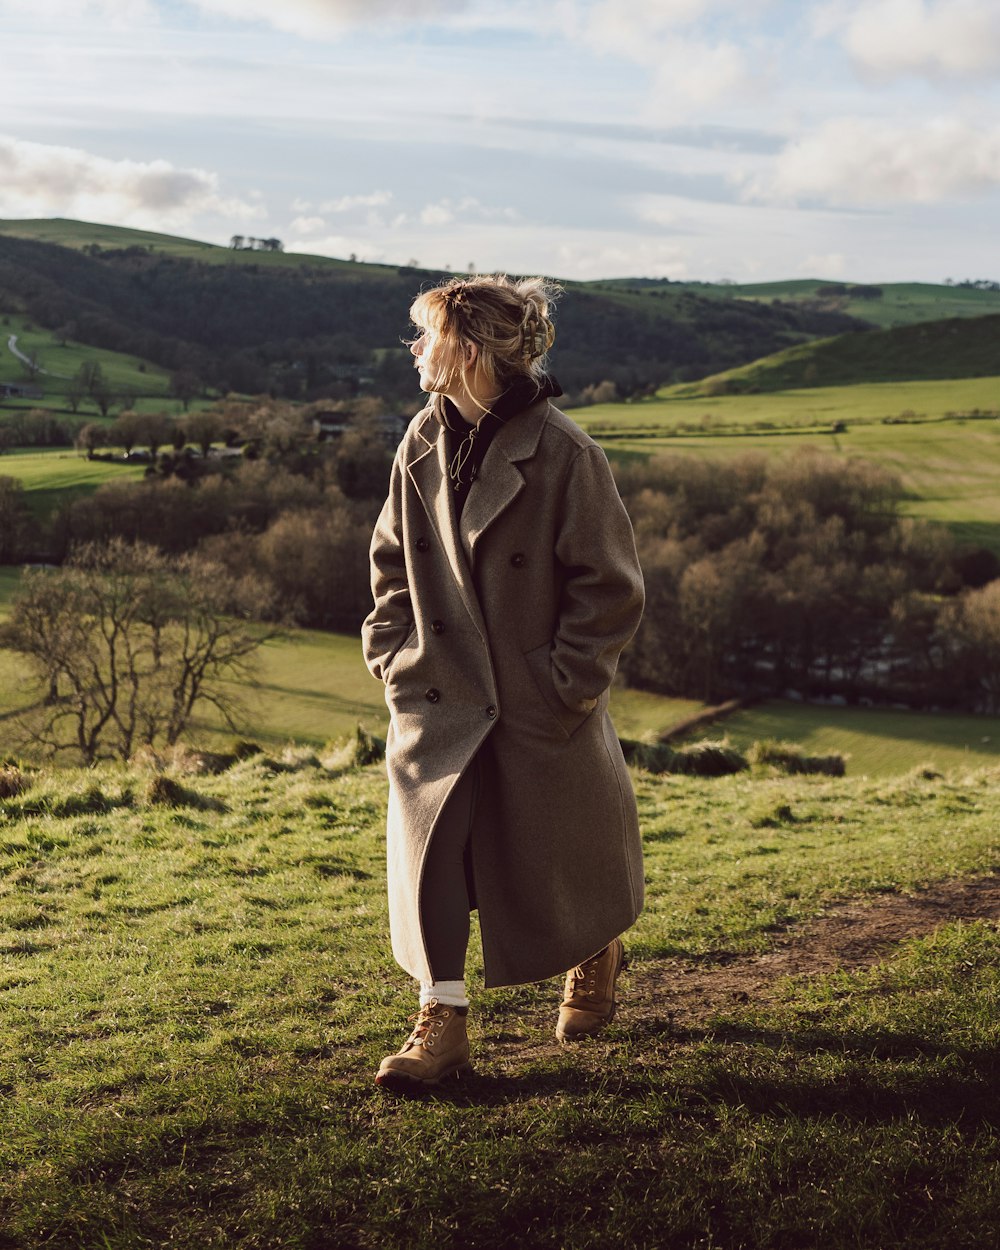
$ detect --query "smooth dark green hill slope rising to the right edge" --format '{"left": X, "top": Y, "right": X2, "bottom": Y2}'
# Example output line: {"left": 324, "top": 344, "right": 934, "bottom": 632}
{"left": 669, "top": 314, "right": 1000, "bottom": 401}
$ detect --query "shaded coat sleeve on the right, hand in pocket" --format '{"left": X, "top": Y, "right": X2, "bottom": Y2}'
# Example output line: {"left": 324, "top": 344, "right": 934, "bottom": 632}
{"left": 551, "top": 445, "right": 644, "bottom": 711}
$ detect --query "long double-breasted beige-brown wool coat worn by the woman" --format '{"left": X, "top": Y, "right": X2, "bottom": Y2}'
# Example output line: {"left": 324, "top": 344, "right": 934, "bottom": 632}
{"left": 363, "top": 400, "right": 643, "bottom": 986}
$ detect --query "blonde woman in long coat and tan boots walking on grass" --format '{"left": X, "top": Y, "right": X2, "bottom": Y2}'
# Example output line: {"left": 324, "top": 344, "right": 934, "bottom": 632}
{"left": 363, "top": 276, "right": 643, "bottom": 1093}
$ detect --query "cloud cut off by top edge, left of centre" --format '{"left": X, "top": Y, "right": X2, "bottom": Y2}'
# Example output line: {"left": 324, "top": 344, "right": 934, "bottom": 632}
{"left": 194, "top": 0, "right": 468, "bottom": 39}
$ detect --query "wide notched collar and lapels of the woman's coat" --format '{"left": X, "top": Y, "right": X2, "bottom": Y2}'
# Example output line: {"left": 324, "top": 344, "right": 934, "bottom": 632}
{"left": 406, "top": 399, "right": 550, "bottom": 639}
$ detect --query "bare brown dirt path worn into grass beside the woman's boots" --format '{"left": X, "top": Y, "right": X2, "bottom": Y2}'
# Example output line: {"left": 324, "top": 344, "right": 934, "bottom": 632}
{"left": 630, "top": 876, "right": 1000, "bottom": 1026}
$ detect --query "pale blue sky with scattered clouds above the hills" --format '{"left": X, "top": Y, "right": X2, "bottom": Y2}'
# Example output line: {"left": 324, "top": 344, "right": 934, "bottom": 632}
{"left": 0, "top": 0, "right": 1000, "bottom": 283}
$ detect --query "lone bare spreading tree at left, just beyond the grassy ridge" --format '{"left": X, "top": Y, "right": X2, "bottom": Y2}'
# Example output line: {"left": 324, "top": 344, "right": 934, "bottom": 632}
{"left": 0, "top": 540, "right": 278, "bottom": 764}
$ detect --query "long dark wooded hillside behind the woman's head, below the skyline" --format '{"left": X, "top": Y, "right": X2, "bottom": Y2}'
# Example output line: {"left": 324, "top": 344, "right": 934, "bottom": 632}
{"left": 0, "top": 220, "right": 858, "bottom": 399}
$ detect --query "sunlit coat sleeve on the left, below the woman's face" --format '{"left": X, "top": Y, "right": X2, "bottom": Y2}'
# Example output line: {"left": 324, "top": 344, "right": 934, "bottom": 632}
{"left": 361, "top": 446, "right": 414, "bottom": 681}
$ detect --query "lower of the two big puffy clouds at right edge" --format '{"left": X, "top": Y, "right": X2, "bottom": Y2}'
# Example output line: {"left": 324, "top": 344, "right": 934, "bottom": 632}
{"left": 744, "top": 118, "right": 1000, "bottom": 204}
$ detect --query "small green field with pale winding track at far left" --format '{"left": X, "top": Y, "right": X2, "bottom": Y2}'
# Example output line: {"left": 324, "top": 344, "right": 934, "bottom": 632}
{"left": 0, "top": 314, "right": 170, "bottom": 397}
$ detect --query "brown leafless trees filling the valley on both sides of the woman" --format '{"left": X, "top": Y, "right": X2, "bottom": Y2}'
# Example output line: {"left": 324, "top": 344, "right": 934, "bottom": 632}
{"left": 7, "top": 401, "right": 1000, "bottom": 755}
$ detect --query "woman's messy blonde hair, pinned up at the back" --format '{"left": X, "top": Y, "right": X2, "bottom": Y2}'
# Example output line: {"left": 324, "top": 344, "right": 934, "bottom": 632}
{"left": 410, "top": 274, "right": 560, "bottom": 408}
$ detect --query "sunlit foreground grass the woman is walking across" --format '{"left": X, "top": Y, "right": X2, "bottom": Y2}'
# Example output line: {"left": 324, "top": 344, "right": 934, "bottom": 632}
{"left": 0, "top": 754, "right": 1000, "bottom": 1250}
